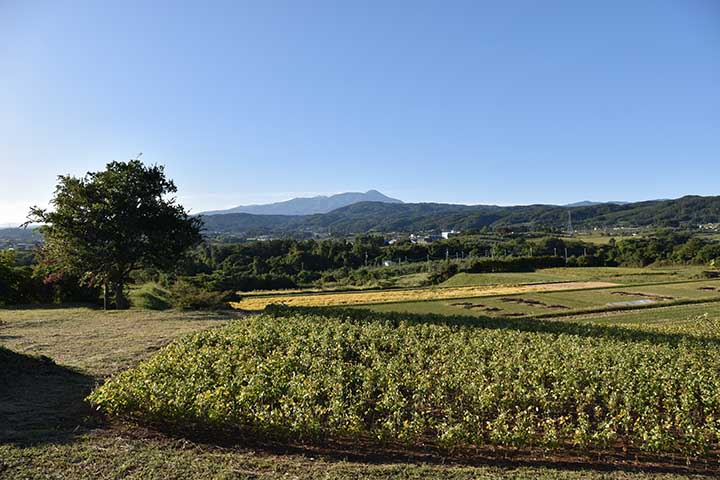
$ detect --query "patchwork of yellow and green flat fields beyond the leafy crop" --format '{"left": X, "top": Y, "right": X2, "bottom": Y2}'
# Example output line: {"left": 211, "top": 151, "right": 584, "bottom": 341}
{"left": 232, "top": 267, "right": 717, "bottom": 316}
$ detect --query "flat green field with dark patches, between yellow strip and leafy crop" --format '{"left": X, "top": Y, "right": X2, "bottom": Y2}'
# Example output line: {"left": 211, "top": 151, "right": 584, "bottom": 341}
{"left": 367, "top": 280, "right": 720, "bottom": 317}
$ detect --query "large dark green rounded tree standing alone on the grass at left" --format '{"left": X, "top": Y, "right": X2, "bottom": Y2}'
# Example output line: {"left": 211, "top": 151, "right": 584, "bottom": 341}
{"left": 28, "top": 159, "right": 202, "bottom": 309}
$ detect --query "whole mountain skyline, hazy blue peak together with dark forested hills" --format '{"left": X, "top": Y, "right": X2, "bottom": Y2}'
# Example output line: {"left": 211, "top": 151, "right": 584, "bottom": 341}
{"left": 7, "top": 190, "right": 720, "bottom": 241}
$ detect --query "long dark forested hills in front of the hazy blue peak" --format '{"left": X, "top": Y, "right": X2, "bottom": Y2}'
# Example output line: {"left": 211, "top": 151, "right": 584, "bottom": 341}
{"left": 204, "top": 192, "right": 720, "bottom": 236}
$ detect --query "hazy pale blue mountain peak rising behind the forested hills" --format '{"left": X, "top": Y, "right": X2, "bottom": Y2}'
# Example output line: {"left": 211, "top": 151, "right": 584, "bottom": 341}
{"left": 201, "top": 190, "right": 403, "bottom": 215}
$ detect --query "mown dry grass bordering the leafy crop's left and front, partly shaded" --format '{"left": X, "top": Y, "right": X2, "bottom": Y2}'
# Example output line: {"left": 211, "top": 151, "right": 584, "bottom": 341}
{"left": 0, "top": 306, "right": 720, "bottom": 479}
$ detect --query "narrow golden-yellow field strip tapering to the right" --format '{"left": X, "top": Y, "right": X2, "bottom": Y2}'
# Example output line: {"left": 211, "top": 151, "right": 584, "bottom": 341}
{"left": 231, "top": 282, "right": 617, "bottom": 310}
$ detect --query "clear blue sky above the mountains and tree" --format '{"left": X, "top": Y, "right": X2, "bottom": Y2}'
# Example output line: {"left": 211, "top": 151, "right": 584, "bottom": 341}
{"left": 0, "top": 0, "right": 720, "bottom": 224}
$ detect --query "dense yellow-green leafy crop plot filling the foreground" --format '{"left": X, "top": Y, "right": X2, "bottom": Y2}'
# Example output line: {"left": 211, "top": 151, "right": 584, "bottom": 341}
{"left": 90, "top": 309, "right": 720, "bottom": 454}
